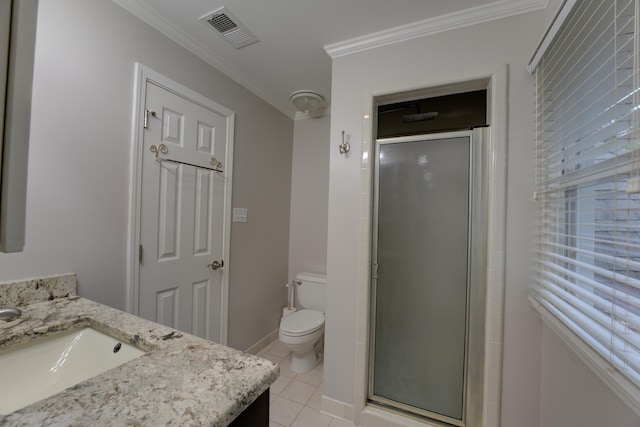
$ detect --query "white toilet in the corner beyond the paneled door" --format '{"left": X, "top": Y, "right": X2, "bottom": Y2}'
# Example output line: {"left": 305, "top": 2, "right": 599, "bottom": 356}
{"left": 279, "top": 273, "right": 327, "bottom": 373}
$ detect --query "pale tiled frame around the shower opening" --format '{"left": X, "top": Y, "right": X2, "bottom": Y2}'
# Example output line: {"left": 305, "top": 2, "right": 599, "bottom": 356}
{"left": 344, "top": 63, "right": 509, "bottom": 427}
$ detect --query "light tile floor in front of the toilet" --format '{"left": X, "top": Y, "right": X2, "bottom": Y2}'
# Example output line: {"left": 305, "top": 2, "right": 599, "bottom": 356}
{"left": 258, "top": 341, "right": 353, "bottom": 427}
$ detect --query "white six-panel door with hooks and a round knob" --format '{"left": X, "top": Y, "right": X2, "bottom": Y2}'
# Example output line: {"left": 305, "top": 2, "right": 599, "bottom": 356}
{"left": 137, "top": 81, "right": 229, "bottom": 342}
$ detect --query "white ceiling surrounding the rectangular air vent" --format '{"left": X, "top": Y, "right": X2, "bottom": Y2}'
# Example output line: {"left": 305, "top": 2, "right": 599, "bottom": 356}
{"left": 114, "top": 0, "right": 546, "bottom": 117}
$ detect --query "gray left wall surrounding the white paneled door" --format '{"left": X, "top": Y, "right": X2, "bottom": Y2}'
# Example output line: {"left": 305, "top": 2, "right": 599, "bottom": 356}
{"left": 0, "top": 0, "right": 293, "bottom": 349}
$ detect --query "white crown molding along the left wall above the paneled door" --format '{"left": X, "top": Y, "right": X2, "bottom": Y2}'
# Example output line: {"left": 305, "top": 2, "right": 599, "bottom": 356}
{"left": 113, "top": 0, "right": 295, "bottom": 119}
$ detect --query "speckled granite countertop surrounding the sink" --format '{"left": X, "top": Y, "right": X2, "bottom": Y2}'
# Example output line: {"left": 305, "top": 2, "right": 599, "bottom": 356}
{"left": 0, "top": 296, "right": 279, "bottom": 426}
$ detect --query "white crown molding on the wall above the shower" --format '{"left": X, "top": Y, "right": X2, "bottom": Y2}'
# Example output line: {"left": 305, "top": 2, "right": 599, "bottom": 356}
{"left": 324, "top": 0, "right": 549, "bottom": 58}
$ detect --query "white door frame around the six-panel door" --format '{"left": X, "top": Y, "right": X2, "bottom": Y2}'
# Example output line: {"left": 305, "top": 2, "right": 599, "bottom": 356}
{"left": 126, "top": 62, "right": 235, "bottom": 345}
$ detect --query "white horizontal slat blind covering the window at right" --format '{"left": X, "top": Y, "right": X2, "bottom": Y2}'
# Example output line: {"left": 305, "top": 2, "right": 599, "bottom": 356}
{"left": 532, "top": 0, "right": 640, "bottom": 394}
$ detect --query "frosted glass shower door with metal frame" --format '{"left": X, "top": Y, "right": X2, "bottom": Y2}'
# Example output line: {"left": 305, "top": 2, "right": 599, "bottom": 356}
{"left": 369, "top": 128, "right": 488, "bottom": 426}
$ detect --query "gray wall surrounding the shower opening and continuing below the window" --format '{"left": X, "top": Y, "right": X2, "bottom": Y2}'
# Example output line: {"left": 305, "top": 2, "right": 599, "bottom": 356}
{"left": 324, "top": 1, "right": 640, "bottom": 427}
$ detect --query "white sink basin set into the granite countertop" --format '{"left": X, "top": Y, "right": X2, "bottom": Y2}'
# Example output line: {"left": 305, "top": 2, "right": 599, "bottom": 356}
{"left": 0, "top": 327, "right": 145, "bottom": 415}
